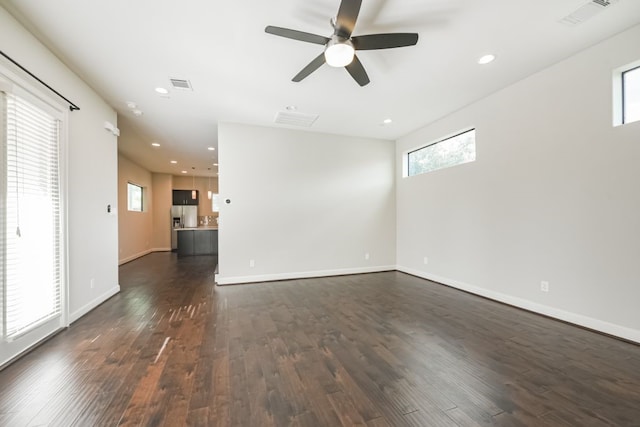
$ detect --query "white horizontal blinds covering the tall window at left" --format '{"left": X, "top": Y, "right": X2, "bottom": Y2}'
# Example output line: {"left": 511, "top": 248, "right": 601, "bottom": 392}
{"left": 0, "top": 92, "right": 62, "bottom": 340}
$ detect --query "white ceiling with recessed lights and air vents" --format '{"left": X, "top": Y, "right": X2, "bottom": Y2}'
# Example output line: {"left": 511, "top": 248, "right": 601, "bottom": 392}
{"left": 0, "top": 0, "right": 640, "bottom": 175}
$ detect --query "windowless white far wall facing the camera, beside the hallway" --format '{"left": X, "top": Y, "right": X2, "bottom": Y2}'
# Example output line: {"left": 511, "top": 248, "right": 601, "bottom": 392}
{"left": 217, "top": 124, "right": 395, "bottom": 284}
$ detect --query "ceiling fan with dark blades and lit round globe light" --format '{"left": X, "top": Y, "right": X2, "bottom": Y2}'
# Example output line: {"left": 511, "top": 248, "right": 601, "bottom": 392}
{"left": 264, "top": 0, "right": 418, "bottom": 86}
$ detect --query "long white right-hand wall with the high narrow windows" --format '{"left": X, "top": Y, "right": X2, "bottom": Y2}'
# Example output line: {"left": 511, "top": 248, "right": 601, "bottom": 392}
{"left": 396, "top": 26, "right": 640, "bottom": 341}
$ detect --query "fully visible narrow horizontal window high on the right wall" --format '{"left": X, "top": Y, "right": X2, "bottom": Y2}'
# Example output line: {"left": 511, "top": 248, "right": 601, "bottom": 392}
{"left": 406, "top": 129, "right": 476, "bottom": 176}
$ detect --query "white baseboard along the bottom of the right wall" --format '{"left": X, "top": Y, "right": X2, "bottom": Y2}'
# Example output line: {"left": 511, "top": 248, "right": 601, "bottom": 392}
{"left": 397, "top": 266, "right": 640, "bottom": 344}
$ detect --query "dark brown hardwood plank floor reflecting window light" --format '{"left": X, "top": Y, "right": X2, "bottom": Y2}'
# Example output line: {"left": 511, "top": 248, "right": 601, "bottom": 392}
{"left": 0, "top": 253, "right": 640, "bottom": 427}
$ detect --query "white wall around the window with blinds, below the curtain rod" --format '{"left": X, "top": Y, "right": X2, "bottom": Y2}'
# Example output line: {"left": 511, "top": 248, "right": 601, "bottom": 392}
{"left": 0, "top": 7, "right": 120, "bottom": 321}
